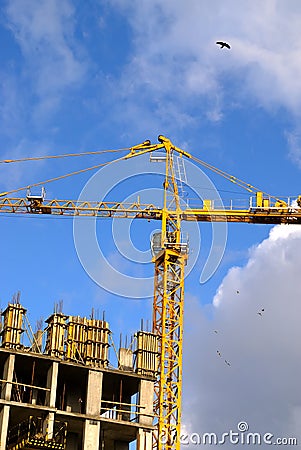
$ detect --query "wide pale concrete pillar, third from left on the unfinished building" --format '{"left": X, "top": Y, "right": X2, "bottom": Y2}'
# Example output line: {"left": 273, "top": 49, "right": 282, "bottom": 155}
{"left": 83, "top": 370, "right": 103, "bottom": 450}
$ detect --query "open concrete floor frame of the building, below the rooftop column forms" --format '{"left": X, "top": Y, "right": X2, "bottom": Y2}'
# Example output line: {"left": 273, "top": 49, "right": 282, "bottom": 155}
{"left": 0, "top": 320, "right": 154, "bottom": 450}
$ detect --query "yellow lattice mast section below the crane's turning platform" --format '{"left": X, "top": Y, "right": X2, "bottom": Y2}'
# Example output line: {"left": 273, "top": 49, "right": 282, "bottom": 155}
{"left": 153, "top": 246, "right": 187, "bottom": 449}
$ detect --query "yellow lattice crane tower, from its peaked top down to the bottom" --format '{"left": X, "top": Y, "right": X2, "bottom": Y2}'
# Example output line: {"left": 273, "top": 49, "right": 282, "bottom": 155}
{"left": 126, "top": 136, "right": 190, "bottom": 450}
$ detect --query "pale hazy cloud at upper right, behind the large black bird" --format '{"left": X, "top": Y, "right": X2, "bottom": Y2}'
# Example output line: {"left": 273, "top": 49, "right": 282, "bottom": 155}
{"left": 112, "top": 0, "right": 301, "bottom": 110}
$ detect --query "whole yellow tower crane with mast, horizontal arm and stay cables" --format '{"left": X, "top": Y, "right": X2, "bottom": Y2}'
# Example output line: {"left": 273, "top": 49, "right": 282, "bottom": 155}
{"left": 0, "top": 136, "right": 301, "bottom": 450}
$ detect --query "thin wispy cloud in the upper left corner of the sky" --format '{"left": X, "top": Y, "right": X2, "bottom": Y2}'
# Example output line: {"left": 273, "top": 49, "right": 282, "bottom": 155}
{"left": 6, "top": 0, "right": 85, "bottom": 113}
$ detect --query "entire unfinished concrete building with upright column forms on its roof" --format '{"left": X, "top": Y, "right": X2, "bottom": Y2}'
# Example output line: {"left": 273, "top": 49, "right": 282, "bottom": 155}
{"left": 0, "top": 301, "right": 158, "bottom": 450}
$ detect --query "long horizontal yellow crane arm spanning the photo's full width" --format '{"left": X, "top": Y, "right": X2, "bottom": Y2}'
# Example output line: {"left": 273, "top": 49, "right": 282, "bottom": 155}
{"left": 0, "top": 198, "right": 301, "bottom": 224}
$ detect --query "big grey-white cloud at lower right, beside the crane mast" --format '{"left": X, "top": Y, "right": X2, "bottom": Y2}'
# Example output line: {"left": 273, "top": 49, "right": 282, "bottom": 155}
{"left": 184, "top": 225, "right": 301, "bottom": 449}
